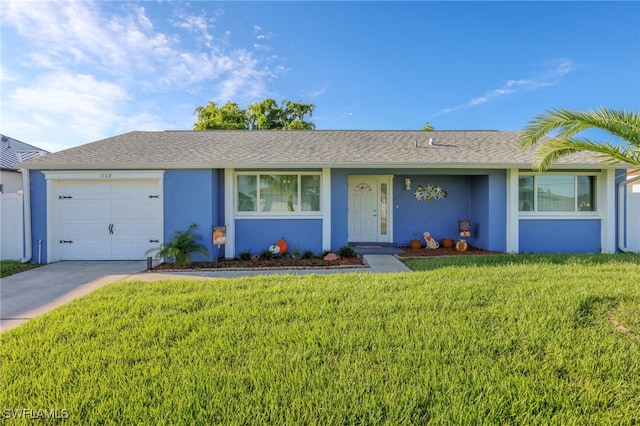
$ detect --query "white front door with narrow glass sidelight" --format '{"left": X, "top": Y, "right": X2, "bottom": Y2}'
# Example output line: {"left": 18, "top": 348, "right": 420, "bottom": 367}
{"left": 348, "top": 176, "right": 392, "bottom": 243}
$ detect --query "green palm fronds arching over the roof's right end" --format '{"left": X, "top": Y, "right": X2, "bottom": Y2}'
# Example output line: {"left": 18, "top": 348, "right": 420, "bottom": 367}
{"left": 520, "top": 108, "right": 640, "bottom": 171}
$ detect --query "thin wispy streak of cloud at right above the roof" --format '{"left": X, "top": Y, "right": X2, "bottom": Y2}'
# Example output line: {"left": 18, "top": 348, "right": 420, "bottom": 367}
{"left": 435, "top": 59, "right": 576, "bottom": 116}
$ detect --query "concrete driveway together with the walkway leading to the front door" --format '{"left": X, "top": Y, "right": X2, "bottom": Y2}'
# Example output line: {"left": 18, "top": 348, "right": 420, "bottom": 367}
{"left": 0, "top": 254, "right": 410, "bottom": 332}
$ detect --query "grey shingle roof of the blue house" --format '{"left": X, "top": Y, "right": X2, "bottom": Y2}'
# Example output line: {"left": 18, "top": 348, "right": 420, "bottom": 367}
{"left": 21, "top": 130, "right": 600, "bottom": 170}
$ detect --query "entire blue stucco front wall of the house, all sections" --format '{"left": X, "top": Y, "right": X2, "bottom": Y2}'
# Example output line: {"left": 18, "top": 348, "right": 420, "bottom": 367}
{"left": 30, "top": 169, "right": 624, "bottom": 262}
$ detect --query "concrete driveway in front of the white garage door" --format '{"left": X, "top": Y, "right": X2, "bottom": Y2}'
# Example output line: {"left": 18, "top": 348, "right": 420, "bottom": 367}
{"left": 0, "top": 261, "right": 147, "bottom": 332}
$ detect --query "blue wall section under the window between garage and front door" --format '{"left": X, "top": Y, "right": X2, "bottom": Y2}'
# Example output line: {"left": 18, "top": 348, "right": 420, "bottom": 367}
{"left": 235, "top": 219, "right": 322, "bottom": 256}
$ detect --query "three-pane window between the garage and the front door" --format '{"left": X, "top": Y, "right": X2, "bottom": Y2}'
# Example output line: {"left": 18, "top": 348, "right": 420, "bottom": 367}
{"left": 236, "top": 173, "right": 320, "bottom": 214}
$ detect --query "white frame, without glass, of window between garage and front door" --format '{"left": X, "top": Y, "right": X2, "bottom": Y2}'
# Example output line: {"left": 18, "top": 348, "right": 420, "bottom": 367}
{"left": 233, "top": 170, "right": 323, "bottom": 219}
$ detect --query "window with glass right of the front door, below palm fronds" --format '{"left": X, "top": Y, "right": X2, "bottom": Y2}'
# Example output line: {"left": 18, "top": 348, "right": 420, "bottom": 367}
{"left": 518, "top": 174, "right": 596, "bottom": 213}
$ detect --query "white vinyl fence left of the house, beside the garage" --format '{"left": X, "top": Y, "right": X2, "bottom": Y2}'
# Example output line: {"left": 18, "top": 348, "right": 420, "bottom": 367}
{"left": 0, "top": 194, "right": 24, "bottom": 260}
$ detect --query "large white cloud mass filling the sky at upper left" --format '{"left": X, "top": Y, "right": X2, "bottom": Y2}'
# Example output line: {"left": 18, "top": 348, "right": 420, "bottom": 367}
{"left": 0, "top": 0, "right": 281, "bottom": 151}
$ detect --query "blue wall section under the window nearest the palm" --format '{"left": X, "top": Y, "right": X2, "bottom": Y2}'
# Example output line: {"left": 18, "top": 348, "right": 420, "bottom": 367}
{"left": 519, "top": 219, "right": 601, "bottom": 253}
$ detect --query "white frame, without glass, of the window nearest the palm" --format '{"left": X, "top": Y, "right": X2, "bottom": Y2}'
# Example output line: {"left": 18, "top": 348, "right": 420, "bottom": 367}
{"left": 517, "top": 171, "right": 603, "bottom": 219}
